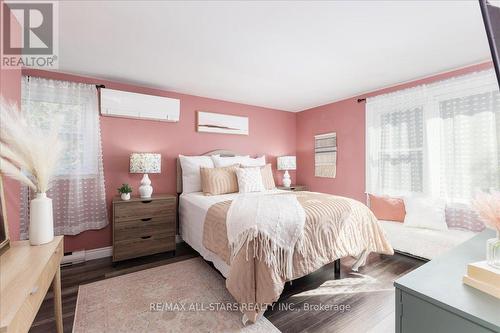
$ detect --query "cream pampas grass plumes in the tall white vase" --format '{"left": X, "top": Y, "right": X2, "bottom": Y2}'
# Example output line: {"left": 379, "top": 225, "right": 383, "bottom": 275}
{"left": 0, "top": 98, "right": 63, "bottom": 193}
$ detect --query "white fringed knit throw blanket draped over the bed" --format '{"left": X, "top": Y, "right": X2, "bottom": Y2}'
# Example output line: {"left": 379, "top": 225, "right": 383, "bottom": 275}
{"left": 226, "top": 193, "right": 306, "bottom": 279}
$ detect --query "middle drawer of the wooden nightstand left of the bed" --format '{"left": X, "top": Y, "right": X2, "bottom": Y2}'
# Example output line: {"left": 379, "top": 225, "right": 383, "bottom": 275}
{"left": 114, "top": 216, "right": 175, "bottom": 241}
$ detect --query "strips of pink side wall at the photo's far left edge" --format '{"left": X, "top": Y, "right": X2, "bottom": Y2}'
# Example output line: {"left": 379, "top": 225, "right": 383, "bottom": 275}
{"left": 0, "top": 1, "right": 21, "bottom": 240}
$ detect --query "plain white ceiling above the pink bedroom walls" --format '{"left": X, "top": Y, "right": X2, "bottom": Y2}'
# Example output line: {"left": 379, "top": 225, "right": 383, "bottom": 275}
{"left": 59, "top": 0, "right": 490, "bottom": 111}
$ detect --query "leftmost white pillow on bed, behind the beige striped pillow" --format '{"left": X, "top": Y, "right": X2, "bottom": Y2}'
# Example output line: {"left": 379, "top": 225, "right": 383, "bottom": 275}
{"left": 179, "top": 155, "right": 214, "bottom": 193}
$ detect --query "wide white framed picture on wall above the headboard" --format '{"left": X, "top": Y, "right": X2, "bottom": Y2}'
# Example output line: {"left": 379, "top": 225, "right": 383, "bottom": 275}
{"left": 196, "top": 111, "right": 248, "bottom": 135}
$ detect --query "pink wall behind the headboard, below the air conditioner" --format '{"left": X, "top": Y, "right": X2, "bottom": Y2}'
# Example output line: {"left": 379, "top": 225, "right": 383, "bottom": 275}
{"left": 23, "top": 70, "right": 296, "bottom": 251}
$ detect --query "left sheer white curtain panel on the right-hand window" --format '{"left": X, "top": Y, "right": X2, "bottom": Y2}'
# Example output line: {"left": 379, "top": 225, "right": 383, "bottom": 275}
{"left": 366, "top": 87, "right": 425, "bottom": 195}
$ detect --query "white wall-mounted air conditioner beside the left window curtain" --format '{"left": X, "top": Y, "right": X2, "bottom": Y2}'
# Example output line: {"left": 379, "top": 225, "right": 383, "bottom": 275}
{"left": 100, "top": 88, "right": 180, "bottom": 122}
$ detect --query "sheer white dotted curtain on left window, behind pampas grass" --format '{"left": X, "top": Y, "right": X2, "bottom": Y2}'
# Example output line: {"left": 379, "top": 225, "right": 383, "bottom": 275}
{"left": 21, "top": 76, "right": 108, "bottom": 238}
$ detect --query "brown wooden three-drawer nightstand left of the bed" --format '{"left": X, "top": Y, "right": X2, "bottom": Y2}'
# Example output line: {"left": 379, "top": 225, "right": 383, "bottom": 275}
{"left": 113, "top": 194, "right": 177, "bottom": 262}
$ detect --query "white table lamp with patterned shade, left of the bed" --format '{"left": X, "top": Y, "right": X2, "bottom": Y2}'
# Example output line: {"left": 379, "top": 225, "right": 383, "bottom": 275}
{"left": 130, "top": 153, "right": 161, "bottom": 198}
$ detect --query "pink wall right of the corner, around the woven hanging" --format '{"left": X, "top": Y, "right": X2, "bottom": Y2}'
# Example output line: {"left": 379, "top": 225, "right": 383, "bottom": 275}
{"left": 296, "top": 62, "right": 492, "bottom": 202}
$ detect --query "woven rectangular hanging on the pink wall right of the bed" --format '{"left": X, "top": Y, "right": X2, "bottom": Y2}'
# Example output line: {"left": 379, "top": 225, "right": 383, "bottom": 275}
{"left": 314, "top": 132, "right": 337, "bottom": 178}
